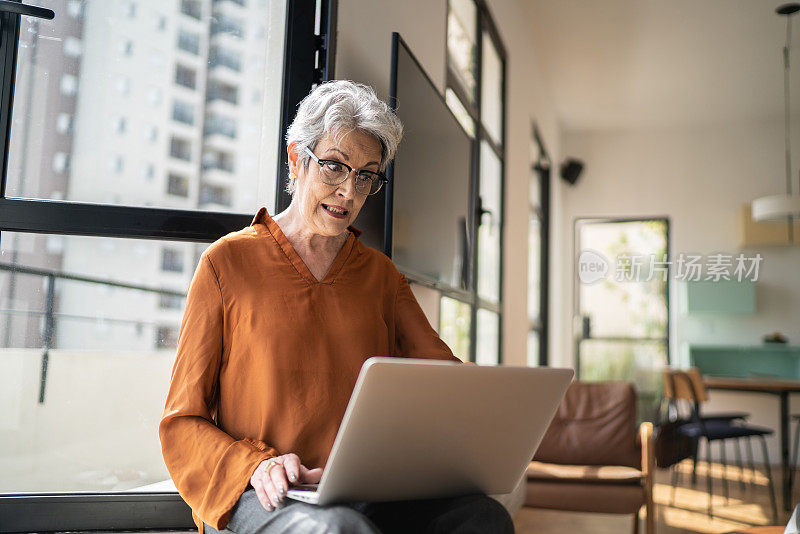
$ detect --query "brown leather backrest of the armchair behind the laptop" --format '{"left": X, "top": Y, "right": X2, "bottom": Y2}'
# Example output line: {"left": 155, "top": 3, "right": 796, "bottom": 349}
{"left": 534, "top": 381, "right": 642, "bottom": 469}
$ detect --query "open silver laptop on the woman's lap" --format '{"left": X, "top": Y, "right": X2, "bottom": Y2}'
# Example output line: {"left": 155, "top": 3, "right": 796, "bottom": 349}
{"left": 287, "top": 357, "right": 574, "bottom": 505}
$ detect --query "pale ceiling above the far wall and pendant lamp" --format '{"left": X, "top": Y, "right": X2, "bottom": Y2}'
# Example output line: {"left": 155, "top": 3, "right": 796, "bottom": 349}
{"left": 528, "top": 0, "right": 800, "bottom": 131}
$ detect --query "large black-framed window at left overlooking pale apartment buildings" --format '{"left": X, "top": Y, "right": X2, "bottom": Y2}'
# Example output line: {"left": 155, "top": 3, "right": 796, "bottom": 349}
{"left": 0, "top": 0, "right": 335, "bottom": 532}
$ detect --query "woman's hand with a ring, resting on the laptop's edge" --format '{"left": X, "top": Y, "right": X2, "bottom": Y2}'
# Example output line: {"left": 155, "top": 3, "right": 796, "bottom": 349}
{"left": 250, "top": 453, "right": 322, "bottom": 512}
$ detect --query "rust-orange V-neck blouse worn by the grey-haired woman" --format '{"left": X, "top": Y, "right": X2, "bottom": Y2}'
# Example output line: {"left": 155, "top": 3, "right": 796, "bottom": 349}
{"left": 159, "top": 208, "right": 459, "bottom": 533}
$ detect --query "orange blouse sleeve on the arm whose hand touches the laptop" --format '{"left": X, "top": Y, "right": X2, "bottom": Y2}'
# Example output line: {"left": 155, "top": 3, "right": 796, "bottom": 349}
{"left": 159, "top": 251, "right": 278, "bottom": 532}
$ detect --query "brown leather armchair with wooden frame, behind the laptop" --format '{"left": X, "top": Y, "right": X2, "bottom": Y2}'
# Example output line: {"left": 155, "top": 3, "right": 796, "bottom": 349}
{"left": 525, "top": 381, "right": 655, "bottom": 534}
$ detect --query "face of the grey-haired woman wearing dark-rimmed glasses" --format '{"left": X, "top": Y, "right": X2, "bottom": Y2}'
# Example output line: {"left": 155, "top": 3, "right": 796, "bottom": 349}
{"left": 289, "top": 130, "right": 381, "bottom": 237}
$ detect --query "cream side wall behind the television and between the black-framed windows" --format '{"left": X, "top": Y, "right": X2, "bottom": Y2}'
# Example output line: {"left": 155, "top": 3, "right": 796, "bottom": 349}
{"left": 336, "top": 0, "right": 563, "bottom": 365}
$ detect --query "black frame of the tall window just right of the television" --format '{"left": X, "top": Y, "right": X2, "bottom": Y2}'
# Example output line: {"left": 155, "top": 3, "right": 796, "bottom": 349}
{"left": 440, "top": 0, "right": 508, "bottom": 365}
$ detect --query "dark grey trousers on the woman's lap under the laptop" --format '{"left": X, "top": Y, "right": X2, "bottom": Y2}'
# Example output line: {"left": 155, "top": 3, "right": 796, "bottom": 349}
{"left": 205, "top": 489, "right": 514, "bottom": 534}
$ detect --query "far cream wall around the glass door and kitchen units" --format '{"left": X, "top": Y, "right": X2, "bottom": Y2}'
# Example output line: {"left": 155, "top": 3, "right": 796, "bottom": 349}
{"left": 557, "top": 116, "right": 800, "bottom": 461}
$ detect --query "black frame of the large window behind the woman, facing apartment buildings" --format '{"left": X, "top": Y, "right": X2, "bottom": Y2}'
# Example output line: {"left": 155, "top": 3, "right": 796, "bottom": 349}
{"left": 0, "top": 0, "right": 337, "bottom": 532}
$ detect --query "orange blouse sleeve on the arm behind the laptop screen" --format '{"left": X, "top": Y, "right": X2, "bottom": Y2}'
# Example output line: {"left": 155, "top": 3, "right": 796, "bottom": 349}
{"left": 395, "top": 274, "right": 461, "bottom": 362}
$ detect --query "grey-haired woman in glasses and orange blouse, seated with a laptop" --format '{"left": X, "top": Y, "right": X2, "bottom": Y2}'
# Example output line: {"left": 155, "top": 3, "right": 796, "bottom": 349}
{"left": 159, "top": 81, "right": 513, "bottom": 534}
